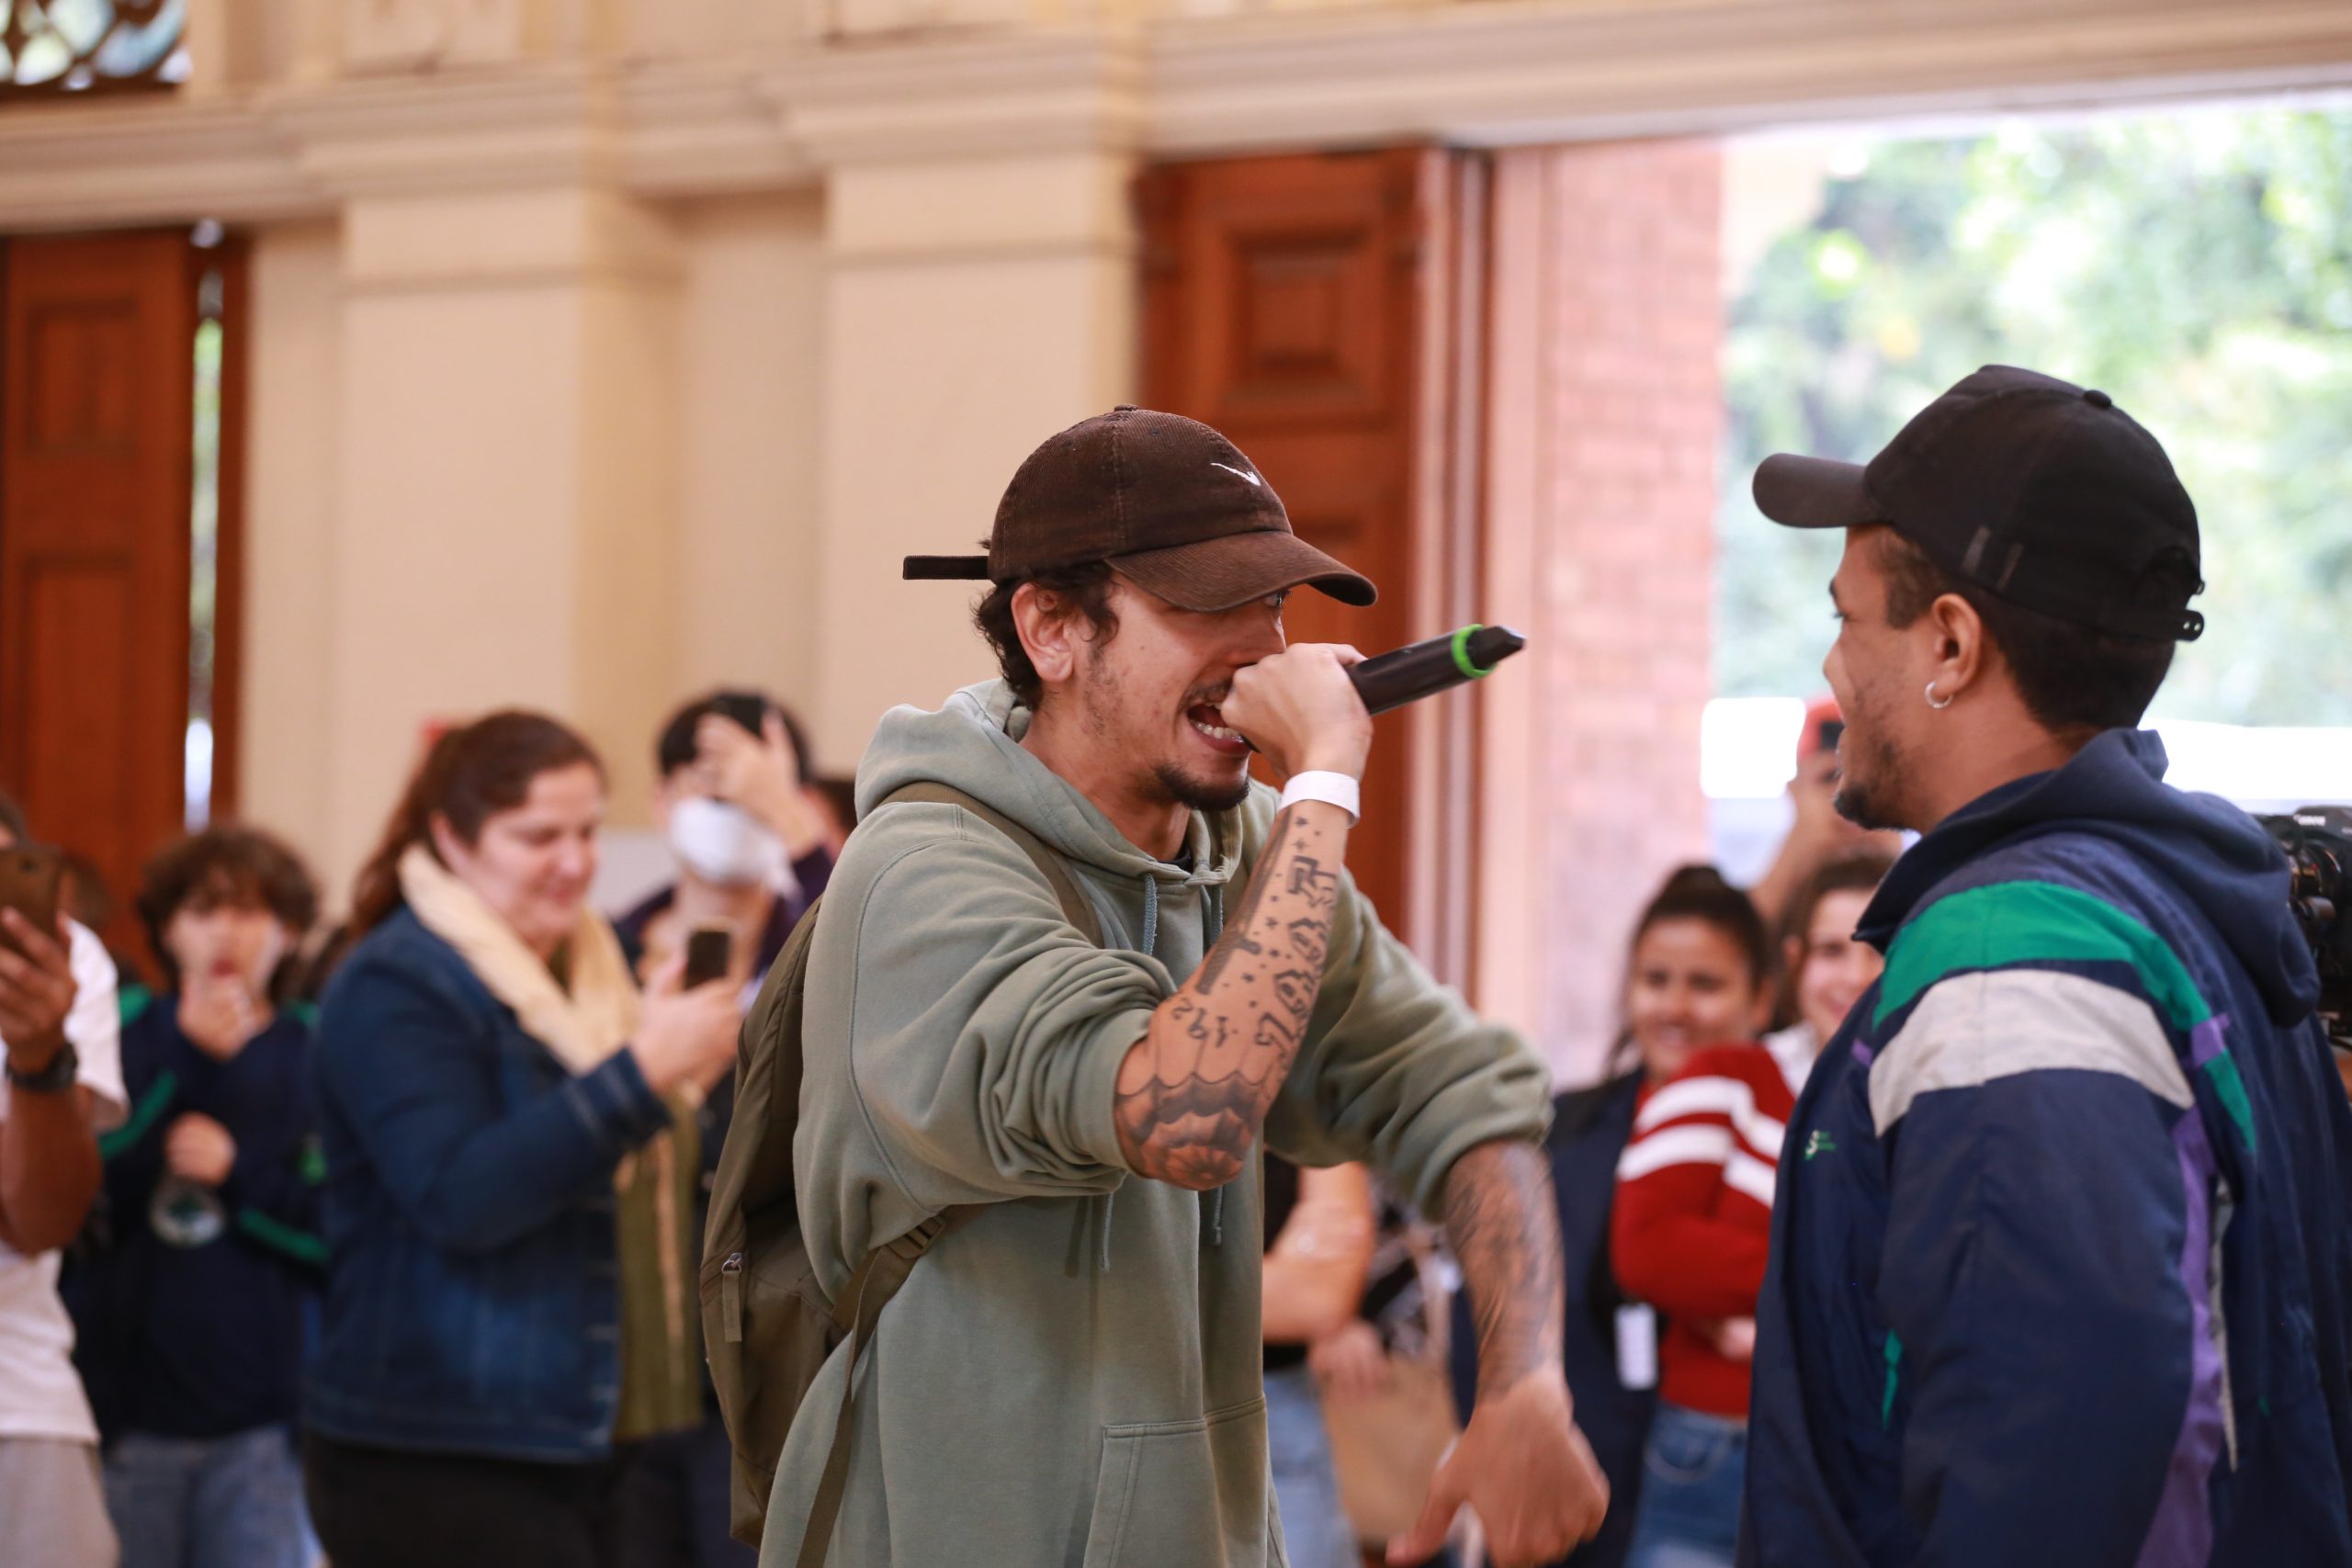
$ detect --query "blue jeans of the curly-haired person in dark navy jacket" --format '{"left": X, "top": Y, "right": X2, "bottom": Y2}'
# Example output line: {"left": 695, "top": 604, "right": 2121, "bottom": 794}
{"left": 106, "top": 1427, "right": 318, "bottom": 1568}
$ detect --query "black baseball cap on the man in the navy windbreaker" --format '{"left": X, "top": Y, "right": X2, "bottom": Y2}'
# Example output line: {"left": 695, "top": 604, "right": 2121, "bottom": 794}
{"left": 1755, "top": 365, "right": 2204, "bottom": 642}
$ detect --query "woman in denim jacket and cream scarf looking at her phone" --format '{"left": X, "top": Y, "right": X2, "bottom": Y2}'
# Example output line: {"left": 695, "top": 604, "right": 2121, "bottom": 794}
{"left": 306, "top": 712, "right": 736, "bottom": 1568}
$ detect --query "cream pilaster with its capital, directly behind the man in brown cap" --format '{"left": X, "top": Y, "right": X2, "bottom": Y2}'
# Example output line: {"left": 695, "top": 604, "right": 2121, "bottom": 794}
{"left": 781, "top": 40, "right": 1138, "bottom": 761}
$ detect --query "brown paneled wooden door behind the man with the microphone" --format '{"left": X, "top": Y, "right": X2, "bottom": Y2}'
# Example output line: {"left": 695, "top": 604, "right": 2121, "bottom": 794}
{"left": 1141, "top": 148, "right": 1465, "bottom": 936}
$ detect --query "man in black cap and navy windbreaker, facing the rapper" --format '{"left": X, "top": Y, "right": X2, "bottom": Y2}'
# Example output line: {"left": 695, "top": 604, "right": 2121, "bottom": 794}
{"left": 1740, "top": 367, "right": 2352, "bottom": 1568}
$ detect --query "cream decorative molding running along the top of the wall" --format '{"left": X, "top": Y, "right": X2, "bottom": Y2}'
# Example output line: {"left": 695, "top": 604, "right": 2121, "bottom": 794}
{"left": 0, "top": 0, "right": 2352, "bottom": 231}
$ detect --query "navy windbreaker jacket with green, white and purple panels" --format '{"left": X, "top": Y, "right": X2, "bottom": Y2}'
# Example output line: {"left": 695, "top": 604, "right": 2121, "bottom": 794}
{"left": 1738, "top": 731, "right": 2352, "bottom": 1568}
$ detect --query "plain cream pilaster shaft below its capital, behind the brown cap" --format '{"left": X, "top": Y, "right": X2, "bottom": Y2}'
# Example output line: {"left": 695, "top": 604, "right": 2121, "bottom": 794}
{"left": 816, "top": 155, "right": 1136, "bottom": 761}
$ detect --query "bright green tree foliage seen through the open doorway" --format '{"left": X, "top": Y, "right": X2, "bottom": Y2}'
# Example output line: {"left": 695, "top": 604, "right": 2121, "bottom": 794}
{"left": 1714, "top": 110, "right": 2352, "bottom": 724}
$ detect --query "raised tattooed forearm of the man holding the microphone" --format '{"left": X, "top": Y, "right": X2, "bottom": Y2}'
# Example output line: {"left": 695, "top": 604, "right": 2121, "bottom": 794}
{"left": 1114, "top": 802, "right": 1348, "bottom": 1190}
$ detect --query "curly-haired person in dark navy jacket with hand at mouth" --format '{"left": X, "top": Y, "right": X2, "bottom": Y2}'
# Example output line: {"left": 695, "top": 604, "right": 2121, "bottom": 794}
{"left": 63, "top": 828, "right": 324, "bottom": 1568}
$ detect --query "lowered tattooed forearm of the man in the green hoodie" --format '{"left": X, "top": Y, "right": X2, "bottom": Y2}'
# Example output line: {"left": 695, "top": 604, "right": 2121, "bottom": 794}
{"left": 1444, "top": 1143, "right": 1564, "bottom": 1396}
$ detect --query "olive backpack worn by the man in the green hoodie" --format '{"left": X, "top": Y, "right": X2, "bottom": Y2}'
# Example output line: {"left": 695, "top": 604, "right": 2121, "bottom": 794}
{"left": 701, "top": 783, "right": 1103, "bottom": 1568}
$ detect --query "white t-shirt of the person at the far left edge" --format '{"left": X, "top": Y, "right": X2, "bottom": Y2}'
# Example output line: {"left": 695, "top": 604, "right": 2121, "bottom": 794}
{"left": 0, "top": 926, "right": 125, "bottom": 1443}
